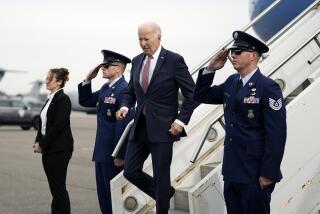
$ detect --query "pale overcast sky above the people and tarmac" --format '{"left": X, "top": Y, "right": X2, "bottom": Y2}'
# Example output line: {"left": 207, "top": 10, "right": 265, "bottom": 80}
{"left": 0, "top": 0, "right": 249, "bottom": 94}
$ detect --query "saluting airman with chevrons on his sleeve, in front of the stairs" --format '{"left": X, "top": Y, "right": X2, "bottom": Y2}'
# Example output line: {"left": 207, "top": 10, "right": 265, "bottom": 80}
{"left": 194, "top": 31, "right": 286, "bottom": 214}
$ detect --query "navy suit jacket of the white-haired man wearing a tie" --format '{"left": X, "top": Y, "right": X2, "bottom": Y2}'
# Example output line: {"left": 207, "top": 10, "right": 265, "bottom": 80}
{"left": 122, "top": 47, "right": 195, "bottom": 142}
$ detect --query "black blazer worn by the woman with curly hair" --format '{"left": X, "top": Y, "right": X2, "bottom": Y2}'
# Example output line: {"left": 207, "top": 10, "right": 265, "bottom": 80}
{"left": 35, "top": 90, "right": 73, "bottom": 154}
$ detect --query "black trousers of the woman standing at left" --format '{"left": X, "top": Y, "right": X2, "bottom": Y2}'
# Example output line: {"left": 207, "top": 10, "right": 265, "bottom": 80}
{"left": 42, "top": 152, "right": 72, "bottom": 214}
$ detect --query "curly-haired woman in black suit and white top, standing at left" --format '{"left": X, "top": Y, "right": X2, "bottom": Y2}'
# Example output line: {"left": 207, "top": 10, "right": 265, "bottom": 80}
{"left": 33, "top": 68, "right": 73, "bottom": 214}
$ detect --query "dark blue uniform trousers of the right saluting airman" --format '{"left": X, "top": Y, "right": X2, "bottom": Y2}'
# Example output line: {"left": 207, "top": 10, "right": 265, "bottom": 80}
{"left": 224, "top": 181, "right": 275, "bottom": 214}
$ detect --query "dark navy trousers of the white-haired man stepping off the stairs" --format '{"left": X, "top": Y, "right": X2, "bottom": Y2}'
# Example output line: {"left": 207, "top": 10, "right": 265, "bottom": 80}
{"left": 124, "top": 115, "right": 174, "bottom": 214}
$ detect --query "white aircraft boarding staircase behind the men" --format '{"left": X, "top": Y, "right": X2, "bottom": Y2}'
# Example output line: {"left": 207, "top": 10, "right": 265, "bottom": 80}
{"left": 111, "top": 0, "right": 320, "bottom": 214}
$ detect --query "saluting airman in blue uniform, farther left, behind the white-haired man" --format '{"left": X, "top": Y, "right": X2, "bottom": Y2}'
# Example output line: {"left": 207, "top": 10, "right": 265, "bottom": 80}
{"left": 78, "top": 50, "right": 133, "bottom": 214}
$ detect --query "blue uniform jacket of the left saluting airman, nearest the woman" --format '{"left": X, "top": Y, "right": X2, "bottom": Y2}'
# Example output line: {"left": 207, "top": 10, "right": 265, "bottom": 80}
{"left": 78, "top": 77, "right": 134, "bottom": 162}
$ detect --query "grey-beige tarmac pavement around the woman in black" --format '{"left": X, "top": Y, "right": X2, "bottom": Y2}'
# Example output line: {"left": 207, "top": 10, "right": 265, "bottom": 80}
{"left": 0, "top": 113, "right": 100, "bottom": 214}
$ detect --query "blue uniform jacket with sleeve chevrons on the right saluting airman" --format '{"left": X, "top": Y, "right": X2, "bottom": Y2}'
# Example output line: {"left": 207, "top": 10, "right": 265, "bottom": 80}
{"left": 194, "top": 69, "right": 286, "bottom": 183}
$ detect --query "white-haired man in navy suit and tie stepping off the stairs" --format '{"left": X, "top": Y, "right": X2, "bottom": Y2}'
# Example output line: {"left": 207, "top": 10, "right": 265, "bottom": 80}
{"left": 117, "top": 23, "right": 195, "bottom": 214}
